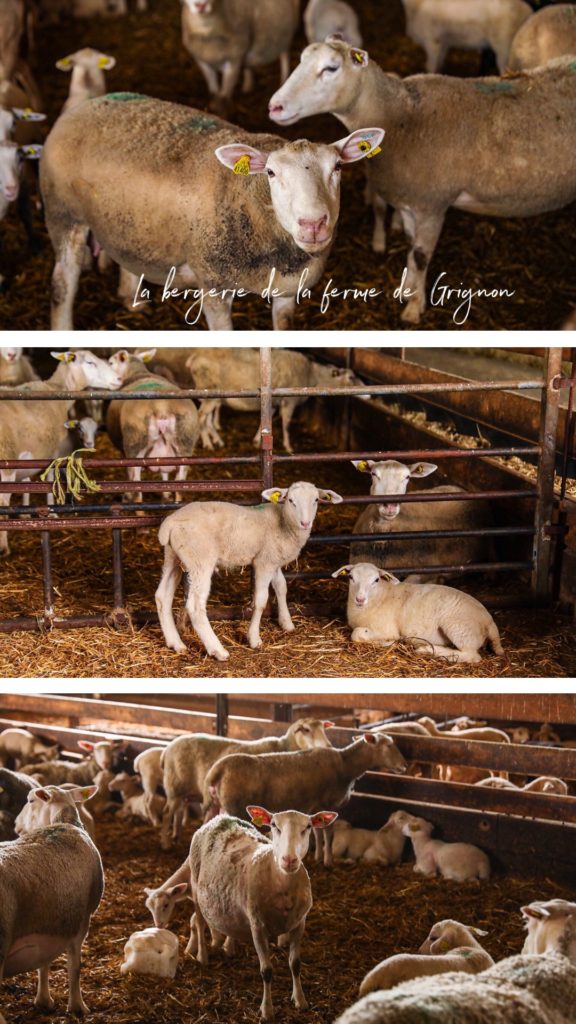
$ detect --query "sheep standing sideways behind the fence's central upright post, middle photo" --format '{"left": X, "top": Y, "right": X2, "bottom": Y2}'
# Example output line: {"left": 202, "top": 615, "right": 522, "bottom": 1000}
{"left": 187, "top": 348, "right": 369, "bottom": 453}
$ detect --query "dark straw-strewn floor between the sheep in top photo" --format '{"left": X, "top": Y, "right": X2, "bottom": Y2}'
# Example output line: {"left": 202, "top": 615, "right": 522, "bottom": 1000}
{"left": 0, "top": 0, "right": 576, "bottom": 331}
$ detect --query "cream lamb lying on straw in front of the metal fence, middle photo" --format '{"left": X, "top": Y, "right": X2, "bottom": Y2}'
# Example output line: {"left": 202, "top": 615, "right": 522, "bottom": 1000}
{"left": 332, "top": 562, "right": 504, "bottom": 663}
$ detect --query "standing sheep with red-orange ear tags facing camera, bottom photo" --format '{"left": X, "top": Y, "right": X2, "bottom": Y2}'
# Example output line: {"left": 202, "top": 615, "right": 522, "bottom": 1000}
{"left": 190, "top": 806, "right": 337, "bottom": 1020}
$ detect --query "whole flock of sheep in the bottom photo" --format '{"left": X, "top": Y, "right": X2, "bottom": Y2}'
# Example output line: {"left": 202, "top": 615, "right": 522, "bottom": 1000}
{"left": 0, "top": 718, "right": 576, "bottom": 1024}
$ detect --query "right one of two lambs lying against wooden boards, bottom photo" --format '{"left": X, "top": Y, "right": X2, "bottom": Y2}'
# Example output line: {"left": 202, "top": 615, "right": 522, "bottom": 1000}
{"left": 404, "top": 818, "right": 490, "bottom": 882}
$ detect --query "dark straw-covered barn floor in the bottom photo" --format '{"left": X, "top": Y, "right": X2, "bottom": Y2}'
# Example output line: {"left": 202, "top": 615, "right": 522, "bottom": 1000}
{"left": 1, "top": 820, "right": 576, "bottom": 1024}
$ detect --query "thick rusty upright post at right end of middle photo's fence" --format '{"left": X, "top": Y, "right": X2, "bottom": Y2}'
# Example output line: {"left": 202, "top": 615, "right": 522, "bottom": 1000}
{"left": 532, "top": 348, "right": 562, "bottom": 600}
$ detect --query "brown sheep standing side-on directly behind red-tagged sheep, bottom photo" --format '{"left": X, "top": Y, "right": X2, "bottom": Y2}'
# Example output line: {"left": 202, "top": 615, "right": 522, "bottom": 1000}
{"left": 204, "top": 732, "right": 406, "bottom": 866}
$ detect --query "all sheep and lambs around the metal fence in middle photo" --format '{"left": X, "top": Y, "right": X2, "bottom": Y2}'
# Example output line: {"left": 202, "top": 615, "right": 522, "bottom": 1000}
{"left": 0, "top": 349, "right": 503, "bottom": 664}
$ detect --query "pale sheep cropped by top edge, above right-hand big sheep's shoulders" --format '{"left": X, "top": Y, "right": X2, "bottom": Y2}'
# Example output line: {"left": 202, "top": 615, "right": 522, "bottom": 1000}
{"left": 403, "top": 0, "right": 532, "bottom": 75}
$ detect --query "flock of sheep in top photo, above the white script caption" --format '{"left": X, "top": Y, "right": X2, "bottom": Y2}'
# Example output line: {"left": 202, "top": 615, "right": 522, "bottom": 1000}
{"left": 0, "top": 0, "right": 576, "bottom": 330}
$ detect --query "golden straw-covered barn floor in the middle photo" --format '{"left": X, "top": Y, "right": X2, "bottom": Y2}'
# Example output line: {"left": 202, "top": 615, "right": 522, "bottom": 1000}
{"left": 0, "top": 411, "right": 576, "bottom": 679}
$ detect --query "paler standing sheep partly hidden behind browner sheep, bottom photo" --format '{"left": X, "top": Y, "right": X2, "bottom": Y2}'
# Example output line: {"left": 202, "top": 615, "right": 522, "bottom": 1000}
{"left": 158, "top": 718, "right": 333, "bottom": 849}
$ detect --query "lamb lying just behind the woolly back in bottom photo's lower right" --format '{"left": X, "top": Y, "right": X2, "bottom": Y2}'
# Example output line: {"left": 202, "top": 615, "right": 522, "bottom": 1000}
{"left": 359, "top": 921, "right": 494, "bottom": 995}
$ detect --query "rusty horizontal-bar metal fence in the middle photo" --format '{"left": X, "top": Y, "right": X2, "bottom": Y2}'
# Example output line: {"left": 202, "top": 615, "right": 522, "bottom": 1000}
{"left": 0, "top": 347, "right": 576, "bottom": 632}
